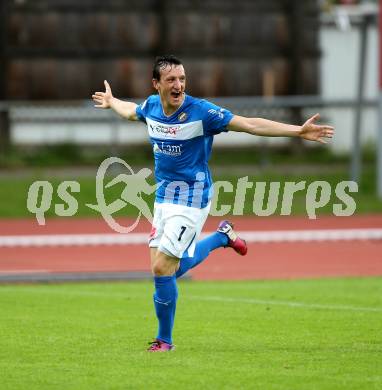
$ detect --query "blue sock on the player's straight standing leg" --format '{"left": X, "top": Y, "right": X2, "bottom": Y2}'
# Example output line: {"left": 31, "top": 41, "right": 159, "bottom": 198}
{"left": 154, "top": 275, "right": 178, "bottom": 344}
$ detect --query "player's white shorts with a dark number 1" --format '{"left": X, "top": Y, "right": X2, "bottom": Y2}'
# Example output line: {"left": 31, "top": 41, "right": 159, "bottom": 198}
{"left": 149, "top": 202, "right": 211, "bottom": 259}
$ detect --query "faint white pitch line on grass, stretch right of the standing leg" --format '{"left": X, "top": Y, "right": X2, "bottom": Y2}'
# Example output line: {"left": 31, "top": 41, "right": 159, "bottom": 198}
{"left": 185, "top": 295, "right": 382, "bottom": 313}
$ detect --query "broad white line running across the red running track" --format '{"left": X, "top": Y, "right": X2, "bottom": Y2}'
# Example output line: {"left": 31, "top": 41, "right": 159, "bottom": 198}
{"left": 0, "top": 228, "right": 382, "bottom": 247}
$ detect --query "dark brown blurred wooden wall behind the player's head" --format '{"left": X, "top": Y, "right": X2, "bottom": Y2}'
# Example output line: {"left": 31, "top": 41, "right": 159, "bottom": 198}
{"left": 1, "top": 0, "right": 320, "bottom": 100}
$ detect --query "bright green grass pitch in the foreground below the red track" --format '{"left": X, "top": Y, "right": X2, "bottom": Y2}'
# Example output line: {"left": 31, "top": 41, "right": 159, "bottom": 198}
{"left": 0, "top": 278, "right": 382, "bottom": 390}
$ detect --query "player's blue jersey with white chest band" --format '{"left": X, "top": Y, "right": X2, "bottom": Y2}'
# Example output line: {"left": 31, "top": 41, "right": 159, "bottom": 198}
{"left": 136, "top": 95, "right": 233, "bottom": 208}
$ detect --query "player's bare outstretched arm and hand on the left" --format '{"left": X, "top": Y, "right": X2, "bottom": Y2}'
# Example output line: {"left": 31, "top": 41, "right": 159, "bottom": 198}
{"left": 92, "top": 80, "right": 138, "bottom": 121}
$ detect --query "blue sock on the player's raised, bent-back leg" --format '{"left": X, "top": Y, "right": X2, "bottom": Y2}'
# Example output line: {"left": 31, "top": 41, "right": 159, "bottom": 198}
{"left": 175, "top": 232, "right": 228, "bottom": 278}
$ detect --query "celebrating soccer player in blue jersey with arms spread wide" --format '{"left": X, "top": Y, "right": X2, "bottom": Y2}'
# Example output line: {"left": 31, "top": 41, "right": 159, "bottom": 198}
{"left": 92, "top": 55, "right": 333, "bottom": 352}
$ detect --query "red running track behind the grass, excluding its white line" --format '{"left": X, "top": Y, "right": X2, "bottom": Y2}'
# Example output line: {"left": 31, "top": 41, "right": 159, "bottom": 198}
{"left": 0, "top": 214, "right": 382, "bottom": 280}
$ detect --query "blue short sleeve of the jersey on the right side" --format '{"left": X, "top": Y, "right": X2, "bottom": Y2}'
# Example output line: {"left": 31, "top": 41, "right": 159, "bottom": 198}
{"left": 201, "top": 100, "right": 233, "bottom": 135}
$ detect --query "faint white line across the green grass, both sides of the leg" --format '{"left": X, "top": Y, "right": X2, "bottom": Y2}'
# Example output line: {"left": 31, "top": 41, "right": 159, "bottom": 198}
{"left": 0, "top": 286, "right": 382, "bottom": 313}
